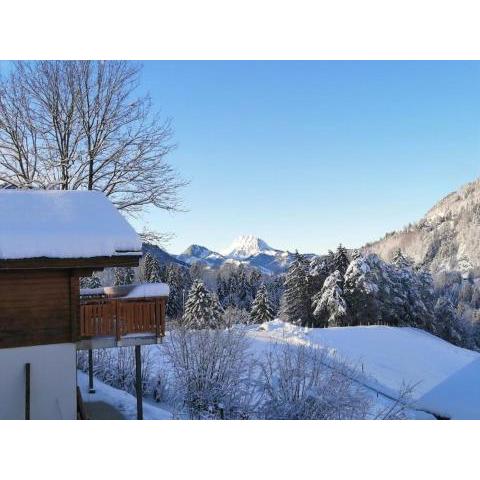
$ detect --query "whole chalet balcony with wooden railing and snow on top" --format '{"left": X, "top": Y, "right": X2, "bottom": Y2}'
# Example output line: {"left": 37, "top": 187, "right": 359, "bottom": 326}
{"left": 77, "top": 283, "right": 169, "bottom": 350}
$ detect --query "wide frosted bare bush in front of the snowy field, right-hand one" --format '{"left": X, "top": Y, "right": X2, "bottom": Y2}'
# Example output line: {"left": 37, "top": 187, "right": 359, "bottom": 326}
{"left": 259, "top": 344, "right": 371, "bottom": 420}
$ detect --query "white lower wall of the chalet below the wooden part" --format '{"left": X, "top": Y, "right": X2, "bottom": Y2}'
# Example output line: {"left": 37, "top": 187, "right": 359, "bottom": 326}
{"left": 0, "top": 343, "right": 77, "bottom": 420}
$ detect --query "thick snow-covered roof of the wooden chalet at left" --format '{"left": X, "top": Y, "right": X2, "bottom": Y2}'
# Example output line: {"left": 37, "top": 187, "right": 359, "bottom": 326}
{"left": 0, "top": 190, "right": 142, "bottom": 260}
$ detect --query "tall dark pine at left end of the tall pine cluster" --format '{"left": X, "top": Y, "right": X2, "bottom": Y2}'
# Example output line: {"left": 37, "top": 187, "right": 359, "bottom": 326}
{"left": 282, "top": 252, "right": 313, "bottom": 326}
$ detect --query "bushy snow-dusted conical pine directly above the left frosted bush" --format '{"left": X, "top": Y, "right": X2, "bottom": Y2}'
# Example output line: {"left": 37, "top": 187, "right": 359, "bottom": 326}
{"left": 183, "top": 280, "right": 223, "bottom": 329}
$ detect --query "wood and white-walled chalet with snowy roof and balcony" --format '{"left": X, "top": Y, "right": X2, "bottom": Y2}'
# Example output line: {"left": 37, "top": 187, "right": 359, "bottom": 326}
{"left": 0, "top": 190, "right": 168, "bottom": 419}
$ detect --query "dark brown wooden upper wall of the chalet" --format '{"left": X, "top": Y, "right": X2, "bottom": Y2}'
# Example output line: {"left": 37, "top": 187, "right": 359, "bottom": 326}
{"left": 0, "top": 270, "right": 79, "bottom": 348}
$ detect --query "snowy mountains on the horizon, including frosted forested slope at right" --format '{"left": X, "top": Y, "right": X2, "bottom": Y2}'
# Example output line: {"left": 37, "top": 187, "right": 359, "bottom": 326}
{"left": 144, "top": 178, "right": 480, "bottom": 277}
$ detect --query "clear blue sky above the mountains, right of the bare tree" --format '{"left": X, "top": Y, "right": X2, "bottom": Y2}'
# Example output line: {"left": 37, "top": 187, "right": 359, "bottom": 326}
{"left": 138, "top": 61, "right": 480, "bottom": 253}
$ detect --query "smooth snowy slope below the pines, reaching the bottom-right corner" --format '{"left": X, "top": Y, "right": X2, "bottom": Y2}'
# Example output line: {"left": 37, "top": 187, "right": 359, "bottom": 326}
{"left": 250, "top": 320, "right": 480, "bottom": 419}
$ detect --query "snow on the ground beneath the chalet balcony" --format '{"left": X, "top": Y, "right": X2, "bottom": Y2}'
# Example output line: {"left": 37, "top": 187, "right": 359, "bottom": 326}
{"left": 77, "top": 370, "right": 172, "bottom": 420}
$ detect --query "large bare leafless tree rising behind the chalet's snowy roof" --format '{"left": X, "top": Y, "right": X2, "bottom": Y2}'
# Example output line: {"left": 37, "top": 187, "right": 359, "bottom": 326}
{"left": 0, "top": 61, "right": 185, "bottom": 214}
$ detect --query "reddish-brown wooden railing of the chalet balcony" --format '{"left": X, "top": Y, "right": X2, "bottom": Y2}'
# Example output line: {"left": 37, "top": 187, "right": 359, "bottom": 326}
{"left": 80, "top": 298, "right": 165, "bottom": 341}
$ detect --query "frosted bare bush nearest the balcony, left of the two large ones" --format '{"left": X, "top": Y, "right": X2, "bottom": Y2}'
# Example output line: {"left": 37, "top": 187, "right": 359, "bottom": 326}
{"left": 164, "top": 328, "right": 252, "bottom": 419}
